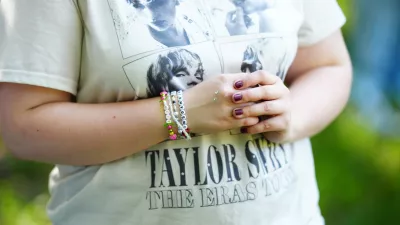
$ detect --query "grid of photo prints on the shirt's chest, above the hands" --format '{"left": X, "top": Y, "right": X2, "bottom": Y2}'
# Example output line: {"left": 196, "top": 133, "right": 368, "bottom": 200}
{"left": 109, "top": 0, "right": 295, "bottom": 98}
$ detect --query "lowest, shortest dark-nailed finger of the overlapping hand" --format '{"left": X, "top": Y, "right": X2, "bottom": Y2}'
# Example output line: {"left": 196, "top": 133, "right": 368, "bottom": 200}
{"left": 247, "top": 114, "right": 289, "bottom": 134}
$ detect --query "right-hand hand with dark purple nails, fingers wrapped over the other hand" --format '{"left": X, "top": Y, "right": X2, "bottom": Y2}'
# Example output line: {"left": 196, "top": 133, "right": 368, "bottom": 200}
{"left": 232, "top": 71, "right": 291, "bottom": 143}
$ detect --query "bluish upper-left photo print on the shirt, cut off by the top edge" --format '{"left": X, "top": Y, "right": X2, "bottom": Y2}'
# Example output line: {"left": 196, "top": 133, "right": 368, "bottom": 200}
{"left": 108, "top": 0, "right": 213, "bottom": 58}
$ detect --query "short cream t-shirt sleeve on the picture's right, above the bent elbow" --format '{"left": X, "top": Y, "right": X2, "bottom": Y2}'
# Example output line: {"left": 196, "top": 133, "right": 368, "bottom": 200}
{"left": 298, "top": 0, "right": 346, "bottom": 46}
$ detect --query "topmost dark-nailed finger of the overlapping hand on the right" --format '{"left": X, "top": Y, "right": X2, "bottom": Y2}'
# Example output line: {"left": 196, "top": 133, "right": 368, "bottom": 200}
{"left": 234, "top": 70, "right": 281, "bottom": 89}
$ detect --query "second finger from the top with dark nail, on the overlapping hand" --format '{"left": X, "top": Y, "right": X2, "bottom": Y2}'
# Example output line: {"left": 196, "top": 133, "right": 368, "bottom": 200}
{"left": 232, "top": 85, "right": 287, "bottom": 103}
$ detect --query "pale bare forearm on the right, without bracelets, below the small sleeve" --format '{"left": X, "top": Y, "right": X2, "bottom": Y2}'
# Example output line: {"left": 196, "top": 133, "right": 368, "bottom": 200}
{"left": 289, "top": 65, "right": 352, "bottom": 141}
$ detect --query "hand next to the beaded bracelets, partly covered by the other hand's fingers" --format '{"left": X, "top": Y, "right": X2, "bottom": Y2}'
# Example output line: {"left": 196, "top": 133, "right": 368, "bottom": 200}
{"left": 183, "top": 73, "right": 259, "bottom": 134}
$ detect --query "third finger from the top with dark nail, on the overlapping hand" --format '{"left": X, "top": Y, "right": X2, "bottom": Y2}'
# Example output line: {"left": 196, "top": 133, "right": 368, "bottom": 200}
{"left": 232, "top": 100, "right": 287, "bottom": 118}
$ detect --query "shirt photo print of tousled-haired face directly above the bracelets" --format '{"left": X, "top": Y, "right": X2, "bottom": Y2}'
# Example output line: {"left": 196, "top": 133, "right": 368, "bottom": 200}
{"left": 123, "top": 42, "right": 222, "bottom": 98}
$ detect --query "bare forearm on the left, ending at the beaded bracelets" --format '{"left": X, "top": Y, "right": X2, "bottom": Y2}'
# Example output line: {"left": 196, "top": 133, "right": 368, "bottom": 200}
{"left": 4, "top": 98, "right": 168, "bottom": 165}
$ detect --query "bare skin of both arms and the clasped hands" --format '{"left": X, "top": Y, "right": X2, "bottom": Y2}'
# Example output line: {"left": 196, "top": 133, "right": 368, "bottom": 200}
{"left": 0, "top": 31, "right": 352, "bottom": 165}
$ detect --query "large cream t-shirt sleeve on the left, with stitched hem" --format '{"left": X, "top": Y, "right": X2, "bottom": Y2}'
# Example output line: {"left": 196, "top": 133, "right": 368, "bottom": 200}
{"left": 0, "top": 0, "right": 83, "bottom": 95}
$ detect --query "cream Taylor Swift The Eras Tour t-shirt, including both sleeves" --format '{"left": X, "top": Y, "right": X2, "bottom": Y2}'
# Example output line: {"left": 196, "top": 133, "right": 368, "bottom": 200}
{"left": 0, "top": 0, "right": 345, "bottom": 225}
